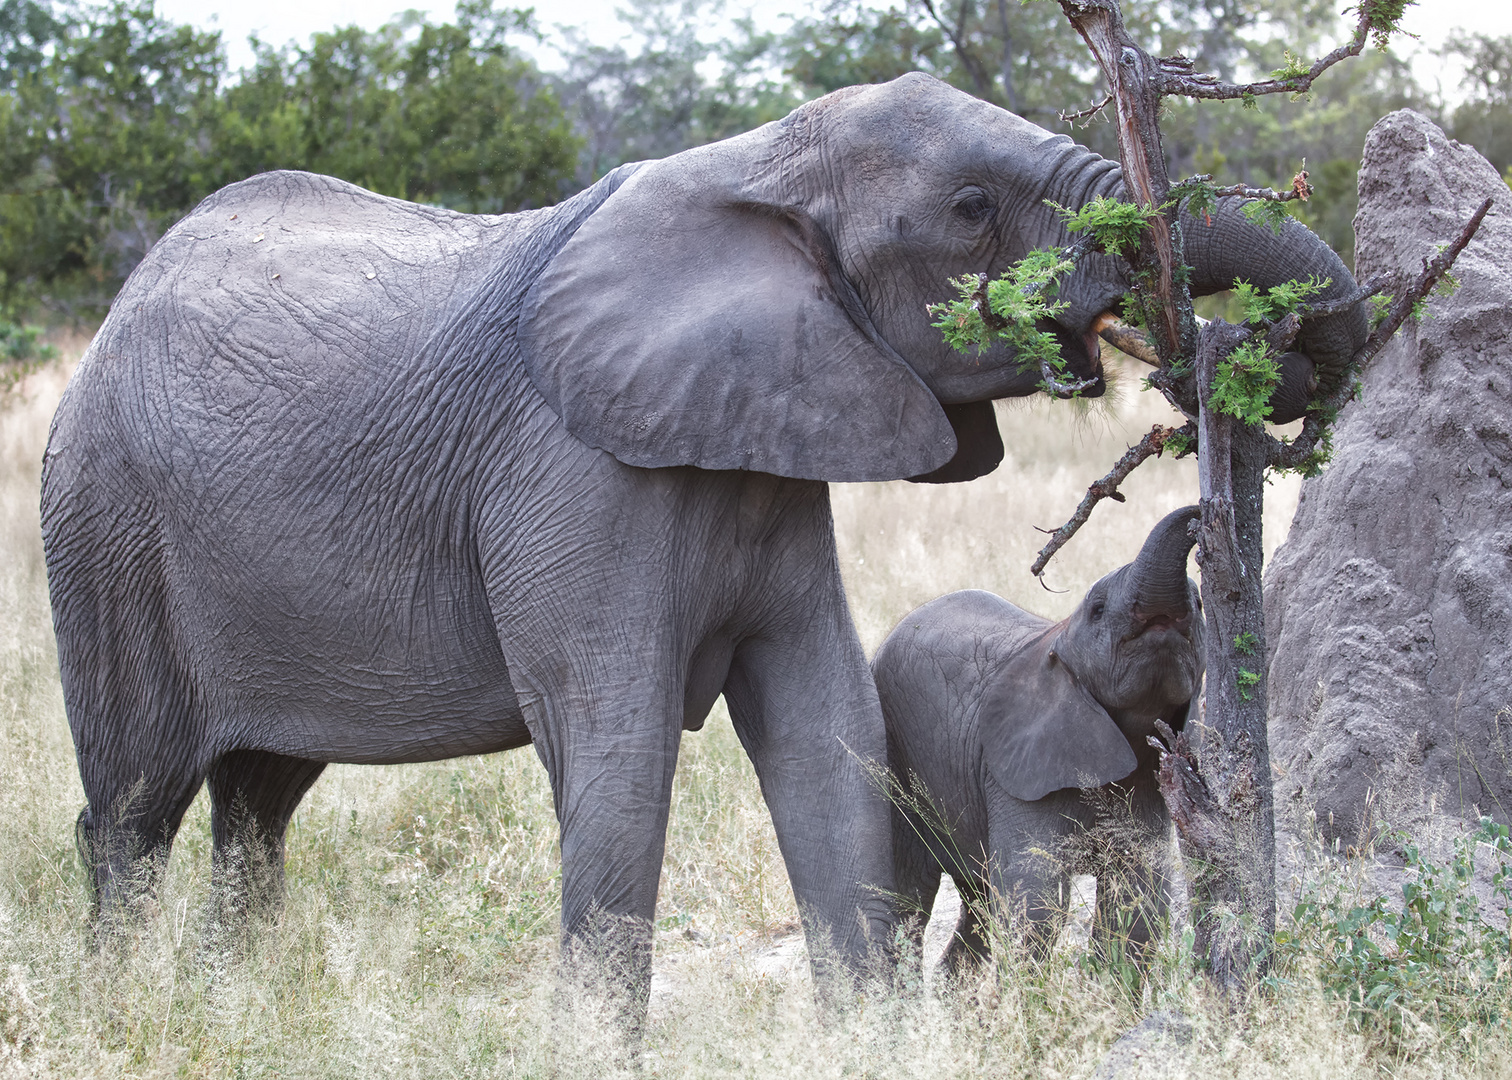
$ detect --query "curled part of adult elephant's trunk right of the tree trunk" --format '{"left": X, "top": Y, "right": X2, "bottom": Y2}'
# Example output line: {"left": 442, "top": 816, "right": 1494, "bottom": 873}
{"left": 1181, "top": 191, "right": 1370, "bottom": 424}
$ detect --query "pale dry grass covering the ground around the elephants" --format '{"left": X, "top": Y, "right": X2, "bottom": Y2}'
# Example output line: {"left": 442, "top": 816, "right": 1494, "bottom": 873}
{"left": 0, "top": 342, "right": 1512, "bottom": 1080}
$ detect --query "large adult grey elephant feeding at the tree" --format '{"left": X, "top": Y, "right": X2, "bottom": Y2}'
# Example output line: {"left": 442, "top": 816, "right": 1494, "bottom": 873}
{"left": 42, "top": 74, "right": 1364, "bottom": 992}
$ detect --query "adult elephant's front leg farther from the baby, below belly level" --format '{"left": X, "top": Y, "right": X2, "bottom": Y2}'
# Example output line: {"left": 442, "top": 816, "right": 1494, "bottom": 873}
{"left": 534, "top": 705, "right": 680, "bottom": 1038}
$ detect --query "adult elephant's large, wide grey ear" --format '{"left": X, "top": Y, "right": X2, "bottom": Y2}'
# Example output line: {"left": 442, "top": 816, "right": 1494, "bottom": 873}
{"left": 519, "top": 124, "right": 957, "bottom": 481}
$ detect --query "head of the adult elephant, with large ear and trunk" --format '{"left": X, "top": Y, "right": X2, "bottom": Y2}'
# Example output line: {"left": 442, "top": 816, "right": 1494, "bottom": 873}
{"left": 519, "top": 74, "right": 1364, "bottom": 481}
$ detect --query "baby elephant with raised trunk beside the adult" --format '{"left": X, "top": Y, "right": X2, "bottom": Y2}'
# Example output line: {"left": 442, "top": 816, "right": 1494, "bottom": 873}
{"left": 872, "top": 507, "right": 1202, "bottom": 971}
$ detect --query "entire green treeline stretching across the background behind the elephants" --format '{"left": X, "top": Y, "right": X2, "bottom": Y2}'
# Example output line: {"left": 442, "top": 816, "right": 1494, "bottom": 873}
{"left": 0, "top": 0, "right": 1512, "bottom": 318}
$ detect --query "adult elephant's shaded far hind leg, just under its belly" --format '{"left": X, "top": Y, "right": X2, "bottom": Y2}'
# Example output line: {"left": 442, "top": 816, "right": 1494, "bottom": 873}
{"left": 210, "top": 750, "right": 325, "bottom": 918}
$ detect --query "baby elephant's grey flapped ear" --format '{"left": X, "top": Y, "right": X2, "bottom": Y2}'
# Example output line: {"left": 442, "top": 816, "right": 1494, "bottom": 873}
{"left": 978, "top": 644, "right": 1139, "bottom": 802}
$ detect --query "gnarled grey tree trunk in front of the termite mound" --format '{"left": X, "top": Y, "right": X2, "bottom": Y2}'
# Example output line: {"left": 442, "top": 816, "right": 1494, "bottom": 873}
{"left": 1061, "top": 0, "right": 1276, "bottom": 997}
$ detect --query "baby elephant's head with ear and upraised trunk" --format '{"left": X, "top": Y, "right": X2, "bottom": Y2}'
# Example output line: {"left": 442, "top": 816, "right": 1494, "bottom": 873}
{"left": 980, "top": 507, "right": 1204, "bottom": 800}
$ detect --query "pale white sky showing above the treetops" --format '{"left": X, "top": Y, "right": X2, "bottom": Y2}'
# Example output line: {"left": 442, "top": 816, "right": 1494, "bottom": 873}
{"left": 157, "top": 0, "right": 1512, "bottom": 97}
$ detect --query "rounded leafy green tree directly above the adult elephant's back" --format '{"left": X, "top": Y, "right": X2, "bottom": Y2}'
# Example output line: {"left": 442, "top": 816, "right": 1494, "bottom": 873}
{"left": 216, "top": 0, "right": 578, "bottom": 213}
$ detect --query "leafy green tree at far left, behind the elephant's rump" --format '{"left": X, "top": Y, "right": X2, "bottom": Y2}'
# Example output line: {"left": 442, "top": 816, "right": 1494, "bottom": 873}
{"left": 0, "top": 0, "right": 225, "bottom": 311}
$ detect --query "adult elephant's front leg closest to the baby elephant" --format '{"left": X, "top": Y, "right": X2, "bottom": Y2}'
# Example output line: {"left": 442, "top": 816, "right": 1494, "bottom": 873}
{"left": 724, "top": 623, "right": 897, "bottom": 992}
